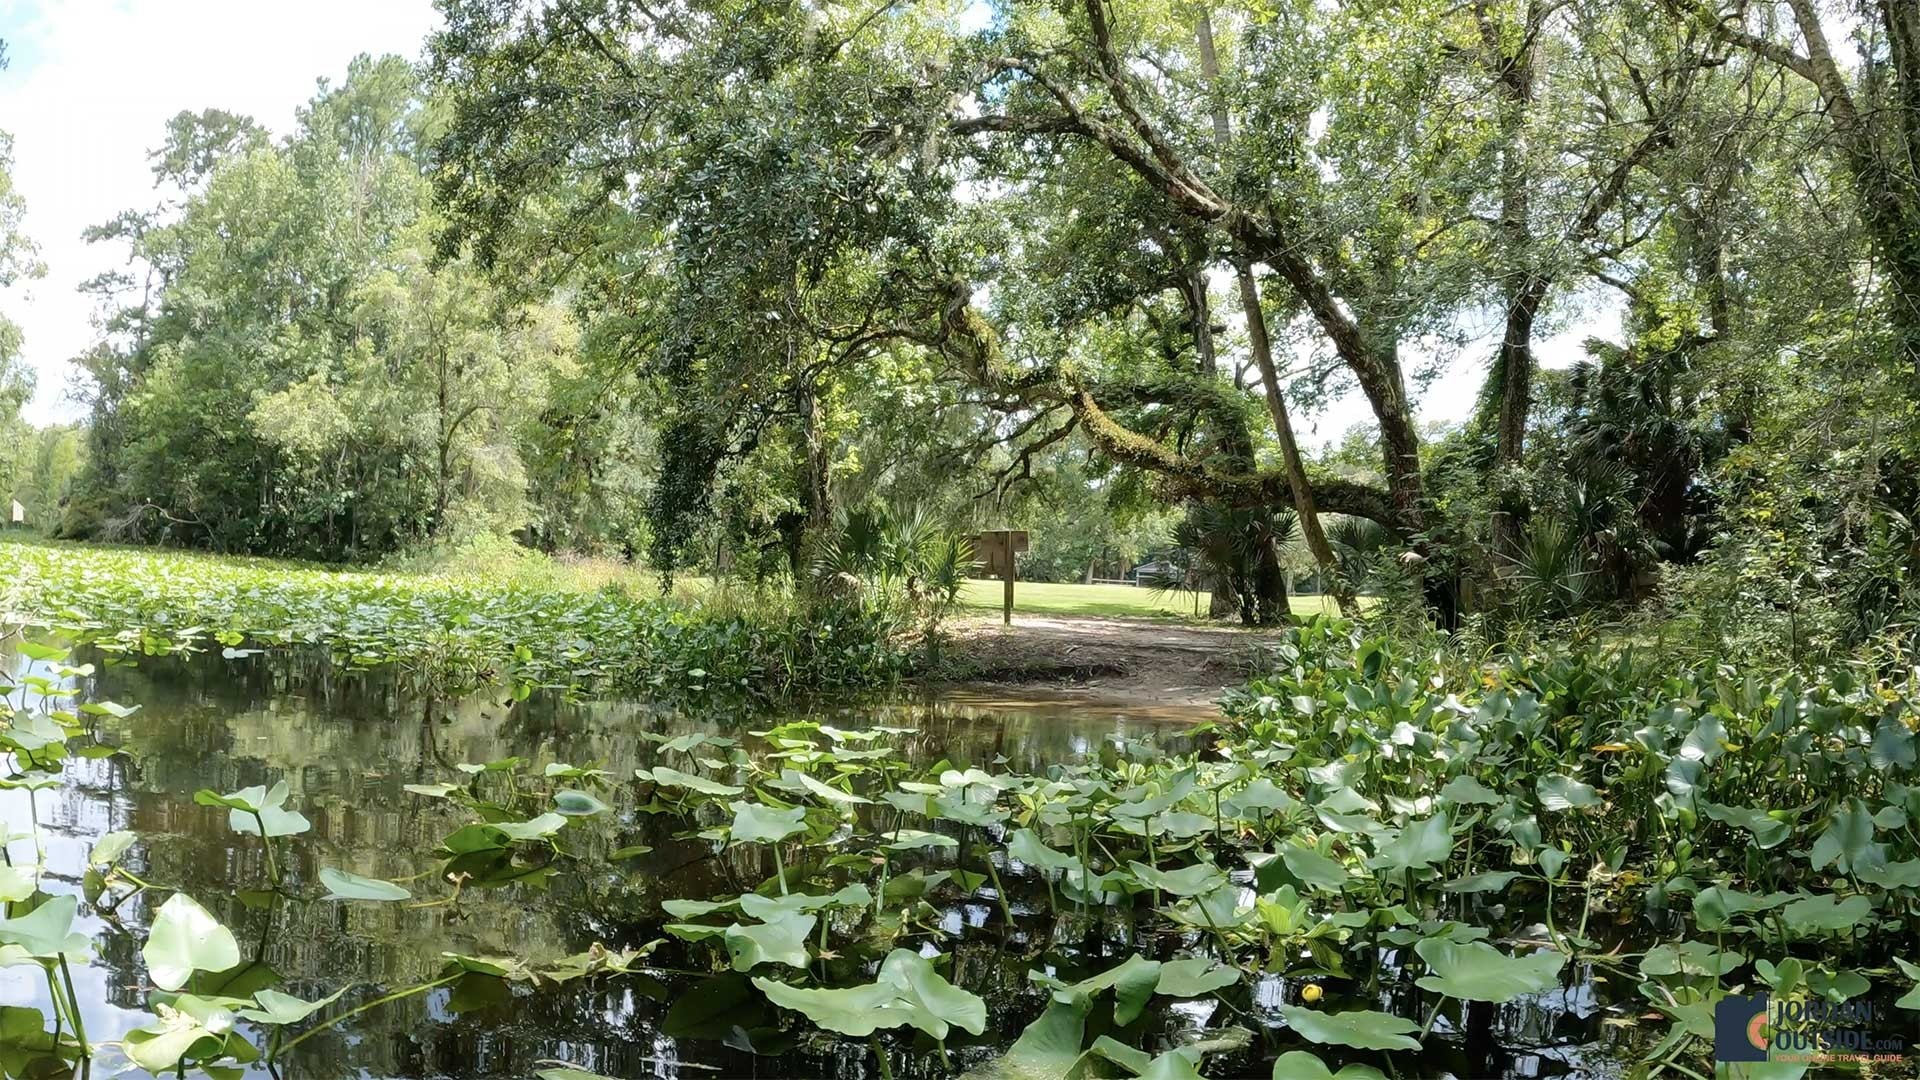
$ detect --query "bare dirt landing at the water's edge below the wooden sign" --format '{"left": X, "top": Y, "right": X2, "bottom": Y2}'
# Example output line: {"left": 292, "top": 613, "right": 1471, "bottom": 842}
{"left": 943, "top": 613, "right": 1273, "bottom": 705}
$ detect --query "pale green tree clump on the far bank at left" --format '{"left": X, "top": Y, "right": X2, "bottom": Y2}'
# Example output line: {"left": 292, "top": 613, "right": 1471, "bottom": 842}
{"left": 67, "top": 58, "right": 606, "bottom": 559}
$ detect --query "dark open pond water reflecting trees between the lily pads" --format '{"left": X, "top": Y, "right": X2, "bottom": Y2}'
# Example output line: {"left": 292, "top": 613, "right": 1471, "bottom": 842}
{"left": 0, "top": 638, "right": 1640, "bottom": 1078}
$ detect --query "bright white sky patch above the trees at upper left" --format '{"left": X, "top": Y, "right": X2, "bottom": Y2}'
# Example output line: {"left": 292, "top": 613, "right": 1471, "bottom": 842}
{"left": 0, "top": 0, "right": 440, "bottom": 423}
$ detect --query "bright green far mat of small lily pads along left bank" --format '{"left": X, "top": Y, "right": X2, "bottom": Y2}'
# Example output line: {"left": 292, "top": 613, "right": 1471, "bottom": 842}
{"left": 0, "top": 542, "right": 906, "bottom": 700}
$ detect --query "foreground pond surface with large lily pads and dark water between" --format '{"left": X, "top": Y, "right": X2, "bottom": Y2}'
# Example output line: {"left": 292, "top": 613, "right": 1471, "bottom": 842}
{"left": 0, "top": 623, "right": 1920, "bottom": 1080}
